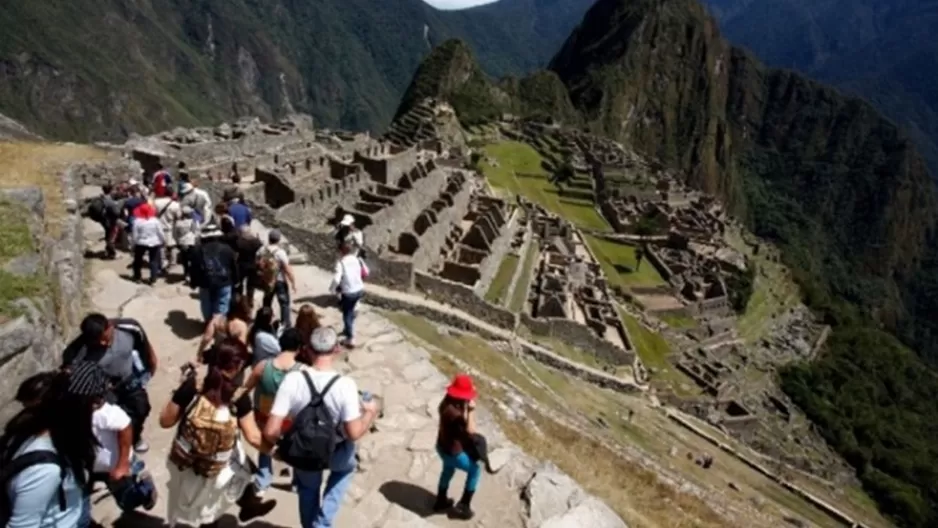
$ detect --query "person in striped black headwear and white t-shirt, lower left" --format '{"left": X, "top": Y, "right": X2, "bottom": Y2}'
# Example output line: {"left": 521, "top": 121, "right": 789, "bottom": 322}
{"left": 79, "top": 362, "right": 157, "bottom": 525}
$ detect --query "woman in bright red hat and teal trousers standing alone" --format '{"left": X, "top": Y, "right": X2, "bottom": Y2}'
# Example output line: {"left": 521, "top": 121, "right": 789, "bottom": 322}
{"left": 433, "top": 374, "right": 482, "bottom": 520}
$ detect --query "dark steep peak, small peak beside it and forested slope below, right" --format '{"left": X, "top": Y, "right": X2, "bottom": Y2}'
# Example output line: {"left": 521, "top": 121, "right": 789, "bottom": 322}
{"left": 399, "top": 0, "right": 938, "bottom": 527}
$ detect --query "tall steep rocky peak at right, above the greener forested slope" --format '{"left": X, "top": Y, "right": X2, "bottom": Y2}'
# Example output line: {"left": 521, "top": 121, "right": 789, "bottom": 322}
{"left": 550, "top": 0, "right": 938, "bottom": 334}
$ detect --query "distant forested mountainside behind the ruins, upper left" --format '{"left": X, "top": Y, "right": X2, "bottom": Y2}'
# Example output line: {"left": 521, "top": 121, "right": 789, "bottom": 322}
{"left": 0, "top": 0, "right": 589, "bottom": 140}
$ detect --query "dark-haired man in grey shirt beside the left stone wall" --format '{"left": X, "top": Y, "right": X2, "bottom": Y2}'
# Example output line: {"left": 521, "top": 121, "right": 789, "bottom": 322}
{"left": 62, "top": 313, "right": 159, "bottom": 453}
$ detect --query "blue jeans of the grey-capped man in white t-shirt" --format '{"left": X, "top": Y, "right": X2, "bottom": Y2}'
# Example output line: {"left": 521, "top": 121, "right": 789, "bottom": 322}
{"left": 293, "top": 440, "right": 356, "bottom": 528}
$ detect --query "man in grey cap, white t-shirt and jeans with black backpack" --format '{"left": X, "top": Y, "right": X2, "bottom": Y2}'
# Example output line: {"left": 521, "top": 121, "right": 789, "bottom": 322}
{"left": 264, "top": 327, "right": 378, "bottom": 528}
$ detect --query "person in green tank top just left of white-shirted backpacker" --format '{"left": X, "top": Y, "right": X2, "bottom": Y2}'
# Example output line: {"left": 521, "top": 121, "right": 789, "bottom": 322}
{"left": 244, "top": 328, "right": 304, "bottom": 492}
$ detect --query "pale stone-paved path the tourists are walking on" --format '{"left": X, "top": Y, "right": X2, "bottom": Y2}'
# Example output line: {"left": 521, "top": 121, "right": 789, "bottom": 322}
{"left": 80, "top": 235, "right": 523, "bottom": 528}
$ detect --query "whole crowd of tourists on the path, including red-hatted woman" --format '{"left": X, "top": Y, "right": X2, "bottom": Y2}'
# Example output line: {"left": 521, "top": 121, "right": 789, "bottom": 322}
{"left": 0, "top": 171, "right": 487, "bottom": 528}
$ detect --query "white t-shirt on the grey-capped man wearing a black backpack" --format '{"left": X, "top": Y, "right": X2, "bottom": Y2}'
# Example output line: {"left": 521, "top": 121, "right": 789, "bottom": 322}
{"left": 270, "top": 367, "right": 362, "bottom": 435}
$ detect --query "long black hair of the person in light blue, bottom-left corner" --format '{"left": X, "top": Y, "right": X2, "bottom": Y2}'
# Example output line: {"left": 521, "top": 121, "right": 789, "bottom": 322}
{"left": 0, "top": 371, "right": 98, "bottom": 486}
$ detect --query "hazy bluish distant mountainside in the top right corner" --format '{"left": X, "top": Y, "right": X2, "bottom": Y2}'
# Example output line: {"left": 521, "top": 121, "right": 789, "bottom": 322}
{"left": 706, "top": 0, "right": 938, "bottom": 175}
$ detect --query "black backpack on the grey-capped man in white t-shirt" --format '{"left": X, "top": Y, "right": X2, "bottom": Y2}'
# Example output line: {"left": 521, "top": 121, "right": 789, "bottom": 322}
{"left": 277, "top": 371, "right": 340, "bottom": 471}
